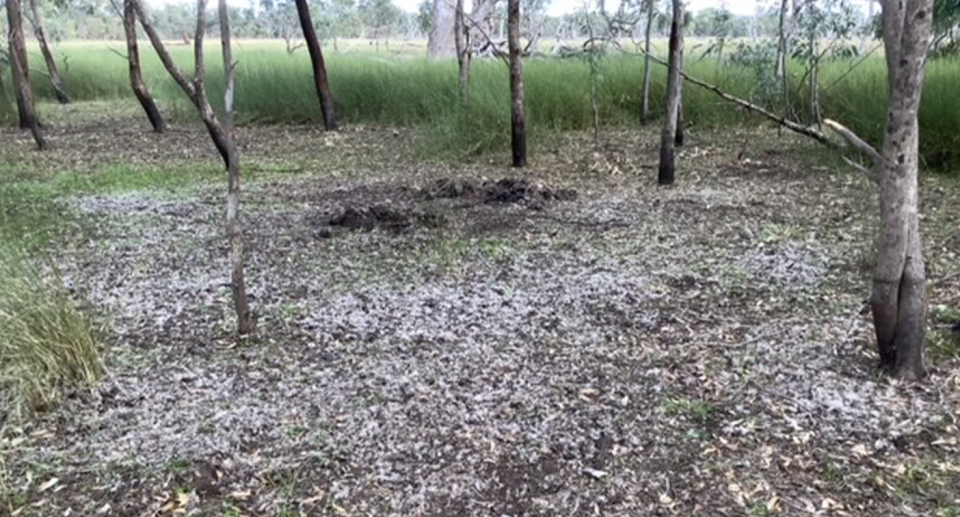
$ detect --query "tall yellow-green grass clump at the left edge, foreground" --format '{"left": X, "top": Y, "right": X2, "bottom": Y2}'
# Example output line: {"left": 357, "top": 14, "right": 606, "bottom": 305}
{"left": 0, "top": 249, "right": 104, "bottom": 415}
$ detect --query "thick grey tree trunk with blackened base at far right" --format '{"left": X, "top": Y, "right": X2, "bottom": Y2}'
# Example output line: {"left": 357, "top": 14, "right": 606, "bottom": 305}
{"left": 870, "top": 0, "right": 933, "bottom": 380}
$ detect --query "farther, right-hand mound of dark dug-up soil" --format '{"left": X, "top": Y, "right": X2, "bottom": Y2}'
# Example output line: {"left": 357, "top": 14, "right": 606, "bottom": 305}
{"left": 421, "top": 178, "right": 577, "bottom": 206}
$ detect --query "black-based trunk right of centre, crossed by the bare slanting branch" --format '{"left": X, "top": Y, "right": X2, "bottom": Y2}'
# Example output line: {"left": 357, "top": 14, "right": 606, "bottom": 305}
{"left": 657, "top": 0, "right": 683, "bottom": 185}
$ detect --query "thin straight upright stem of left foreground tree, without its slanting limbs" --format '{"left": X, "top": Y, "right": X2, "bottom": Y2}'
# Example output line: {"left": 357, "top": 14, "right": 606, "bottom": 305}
{"left": 218, "top": 0, "right": 255, "bottom": 335}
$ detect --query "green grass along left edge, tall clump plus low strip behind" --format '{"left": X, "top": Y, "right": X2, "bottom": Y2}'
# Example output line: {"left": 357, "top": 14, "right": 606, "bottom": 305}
{"left": 0, "top": 159, "right": 222, "bottom": 416}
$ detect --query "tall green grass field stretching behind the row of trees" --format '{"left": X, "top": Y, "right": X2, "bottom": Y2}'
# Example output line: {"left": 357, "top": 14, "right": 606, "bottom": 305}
{"left": 5, "top": 41, "right": 960, "bottom": 170}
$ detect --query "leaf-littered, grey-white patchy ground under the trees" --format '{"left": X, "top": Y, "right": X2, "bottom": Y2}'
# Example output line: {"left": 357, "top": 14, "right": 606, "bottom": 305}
{"left": 0, "top": 103, "right": 960, "bottom": 517}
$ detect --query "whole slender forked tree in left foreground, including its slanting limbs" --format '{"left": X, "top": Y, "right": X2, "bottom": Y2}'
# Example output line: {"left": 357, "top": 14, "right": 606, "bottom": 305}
{"left": 131, "top": 0, "right": 256, "bottom": 335}
